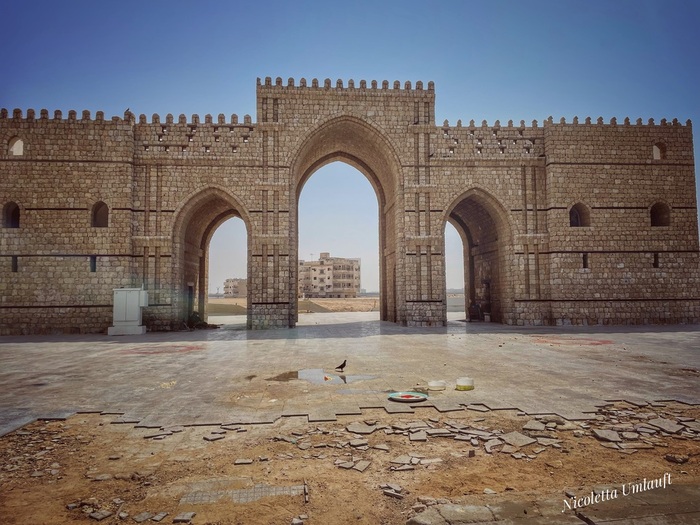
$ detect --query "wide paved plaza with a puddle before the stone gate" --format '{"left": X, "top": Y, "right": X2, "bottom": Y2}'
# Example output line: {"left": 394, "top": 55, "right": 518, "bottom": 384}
{"left": 0, "top": 312, "right": 700, "bottom": 435}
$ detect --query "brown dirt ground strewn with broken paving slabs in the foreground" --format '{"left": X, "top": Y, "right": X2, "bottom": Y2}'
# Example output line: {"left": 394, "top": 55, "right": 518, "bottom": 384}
{"left": 0, "top": 403, "right": 700, "bottom": 525}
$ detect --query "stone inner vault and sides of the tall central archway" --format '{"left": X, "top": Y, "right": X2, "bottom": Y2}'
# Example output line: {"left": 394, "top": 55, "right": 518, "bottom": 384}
{"left": 290, "top": 115, "right": 403, "bottom": 322}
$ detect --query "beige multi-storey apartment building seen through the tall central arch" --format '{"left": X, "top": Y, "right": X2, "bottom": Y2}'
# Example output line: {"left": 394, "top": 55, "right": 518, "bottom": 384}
{"left": 298, "top": 252, "right": 360, "bottom": 298}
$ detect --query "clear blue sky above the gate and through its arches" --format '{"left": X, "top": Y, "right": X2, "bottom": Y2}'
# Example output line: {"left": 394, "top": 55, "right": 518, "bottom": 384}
{"left": 0, "top": 0, "right": 700, "bottom": 291}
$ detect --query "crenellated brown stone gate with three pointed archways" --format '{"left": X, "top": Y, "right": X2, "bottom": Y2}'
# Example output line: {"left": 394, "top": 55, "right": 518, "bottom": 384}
{"left": 0, "top": 78, "right": 700, "bottom": 334}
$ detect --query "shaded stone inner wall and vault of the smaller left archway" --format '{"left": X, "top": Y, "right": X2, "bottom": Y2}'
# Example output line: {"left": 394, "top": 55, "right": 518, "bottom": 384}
{"left": 173, "top": 188, "right": 250, "bottom": 325}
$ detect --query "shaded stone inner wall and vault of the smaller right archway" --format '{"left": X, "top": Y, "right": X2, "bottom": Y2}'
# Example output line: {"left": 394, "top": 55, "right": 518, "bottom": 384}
{"left": 445, "top": 189, "right": 512, "bottom": 322}
